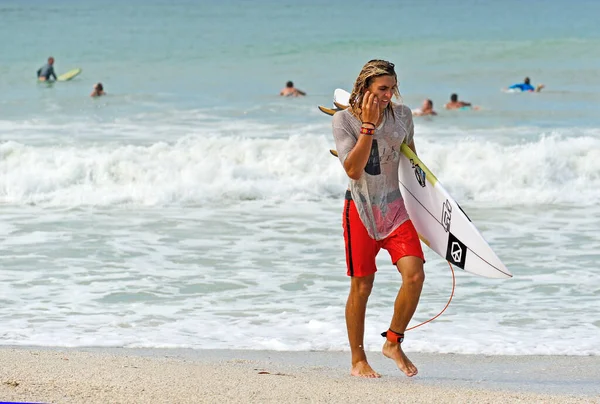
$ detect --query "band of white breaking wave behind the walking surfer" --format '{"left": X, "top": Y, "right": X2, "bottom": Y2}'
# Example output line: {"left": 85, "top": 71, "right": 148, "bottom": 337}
{"left": 0, "top": 124, "right": 600, "bottom": 207}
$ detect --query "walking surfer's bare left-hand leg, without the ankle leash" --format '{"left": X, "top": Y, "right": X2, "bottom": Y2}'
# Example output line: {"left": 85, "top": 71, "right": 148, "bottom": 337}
{"left": 346, "top": 274, "right": 380, "bottom": 377}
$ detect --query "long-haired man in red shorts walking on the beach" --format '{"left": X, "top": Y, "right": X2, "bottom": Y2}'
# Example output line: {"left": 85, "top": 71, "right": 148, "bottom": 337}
{"left": 332, "top": 60, "right": 425, "bottom": 378}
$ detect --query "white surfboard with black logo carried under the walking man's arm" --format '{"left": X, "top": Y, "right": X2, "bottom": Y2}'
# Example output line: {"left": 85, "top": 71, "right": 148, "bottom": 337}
{"left": 324, "top": 89, "right": 512, "bottom": 278}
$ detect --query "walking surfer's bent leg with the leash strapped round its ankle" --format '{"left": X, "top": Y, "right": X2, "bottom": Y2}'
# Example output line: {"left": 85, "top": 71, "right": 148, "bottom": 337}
{"left": 383, "top": 256, "right": 425, "bottom": 376}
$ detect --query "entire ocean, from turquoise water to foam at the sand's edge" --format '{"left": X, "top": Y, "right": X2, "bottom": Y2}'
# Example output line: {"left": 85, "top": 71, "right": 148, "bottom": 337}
{"left": 0, "top": 0, "right": 600, "bottom": 355}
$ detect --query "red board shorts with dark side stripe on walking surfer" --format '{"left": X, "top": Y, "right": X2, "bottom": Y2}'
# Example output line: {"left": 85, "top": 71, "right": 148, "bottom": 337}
{"left": 342, "top": 195, "right": 425, "bottom": 276}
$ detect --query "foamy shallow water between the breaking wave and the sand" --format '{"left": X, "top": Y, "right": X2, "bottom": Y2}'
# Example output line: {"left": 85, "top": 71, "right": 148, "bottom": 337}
{"left": 0, "top": 199, "right": 600, "bottom": 355}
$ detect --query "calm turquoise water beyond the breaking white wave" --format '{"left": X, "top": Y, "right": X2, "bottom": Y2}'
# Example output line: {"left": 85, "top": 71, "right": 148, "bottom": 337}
{"left": 0, "top": 1, "right": 600, "bottom": 126}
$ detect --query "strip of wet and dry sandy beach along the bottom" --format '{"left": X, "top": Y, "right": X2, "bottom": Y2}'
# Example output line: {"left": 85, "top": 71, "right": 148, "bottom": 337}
{"left": 0, "top": 347, "right": 600, "bottom": 403}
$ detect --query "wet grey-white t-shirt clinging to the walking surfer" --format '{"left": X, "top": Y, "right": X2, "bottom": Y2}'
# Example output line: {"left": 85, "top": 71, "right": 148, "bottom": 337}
{"left": 333, "top": 104, "right": 414, "bottom": 240}
